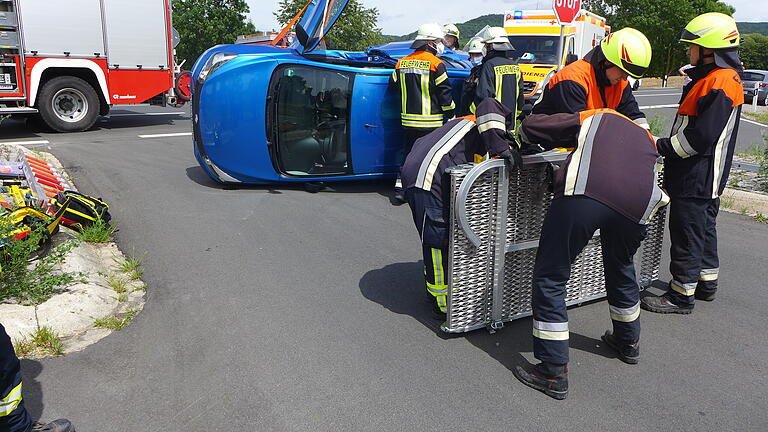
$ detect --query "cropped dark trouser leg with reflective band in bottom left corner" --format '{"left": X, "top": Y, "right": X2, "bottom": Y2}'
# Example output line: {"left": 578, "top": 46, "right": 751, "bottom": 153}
{"left": 0, "top": 324, "right": 32, "bottom": 432}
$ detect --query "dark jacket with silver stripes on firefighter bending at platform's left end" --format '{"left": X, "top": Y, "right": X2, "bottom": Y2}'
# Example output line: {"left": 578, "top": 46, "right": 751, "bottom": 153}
{"left": 400, "top": 98, "right": 515, "bottom": 202}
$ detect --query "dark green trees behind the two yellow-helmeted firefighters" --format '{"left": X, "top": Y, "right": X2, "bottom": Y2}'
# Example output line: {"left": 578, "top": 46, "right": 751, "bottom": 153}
{"left": 584, "top": 0, "right": 734, "bottom": 77}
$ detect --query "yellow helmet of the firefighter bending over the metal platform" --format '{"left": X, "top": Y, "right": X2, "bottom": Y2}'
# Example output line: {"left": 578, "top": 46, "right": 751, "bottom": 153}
{"left": 600, "top": 27, "right": 651, "bottom": 78}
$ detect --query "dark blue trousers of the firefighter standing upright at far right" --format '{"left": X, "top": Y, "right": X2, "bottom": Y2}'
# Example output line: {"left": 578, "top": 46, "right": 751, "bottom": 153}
{"left": 669, "top": 197, "right": 720, "bottom": 305}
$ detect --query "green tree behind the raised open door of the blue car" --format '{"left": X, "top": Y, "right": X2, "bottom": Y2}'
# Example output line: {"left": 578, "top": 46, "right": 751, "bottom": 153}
{"left": 273, "top": 0, "right": 387, "bottom": 51}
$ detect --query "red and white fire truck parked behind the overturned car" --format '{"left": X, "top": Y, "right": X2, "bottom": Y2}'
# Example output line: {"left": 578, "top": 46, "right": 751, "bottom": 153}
{"left": 0, "top": 0, "right": 189, "bottom": 132}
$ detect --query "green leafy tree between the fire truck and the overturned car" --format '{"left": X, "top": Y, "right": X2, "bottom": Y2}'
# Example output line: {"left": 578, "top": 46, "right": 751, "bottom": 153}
{"left": 173, "top": 0, "right": 256, "bottom": 68}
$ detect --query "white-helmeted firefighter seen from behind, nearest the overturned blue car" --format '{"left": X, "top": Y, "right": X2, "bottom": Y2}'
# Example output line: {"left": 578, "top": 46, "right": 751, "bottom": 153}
{"left": 389, "top": 24, "right": 456, "bottom": 203}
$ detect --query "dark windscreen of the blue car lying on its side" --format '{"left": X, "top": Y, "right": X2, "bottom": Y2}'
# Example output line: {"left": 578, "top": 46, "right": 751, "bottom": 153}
{"left": 273, "top": 65, "right": 352, "bottom": 176}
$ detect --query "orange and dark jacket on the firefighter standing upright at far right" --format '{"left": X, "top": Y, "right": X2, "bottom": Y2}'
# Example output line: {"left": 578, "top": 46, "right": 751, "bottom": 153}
{"left": 657, "top": 64, "right": 744, "bottom": 199}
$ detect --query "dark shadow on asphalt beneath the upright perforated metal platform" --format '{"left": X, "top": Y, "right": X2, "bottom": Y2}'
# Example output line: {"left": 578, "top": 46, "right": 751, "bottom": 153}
{"left": 359, "top": 261, "right": 616, "bottom": 371}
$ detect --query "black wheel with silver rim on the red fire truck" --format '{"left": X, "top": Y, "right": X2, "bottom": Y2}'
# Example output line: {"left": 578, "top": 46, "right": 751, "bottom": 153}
{"left": 37, "top": 76, "right": 99, "bottom": 132}
